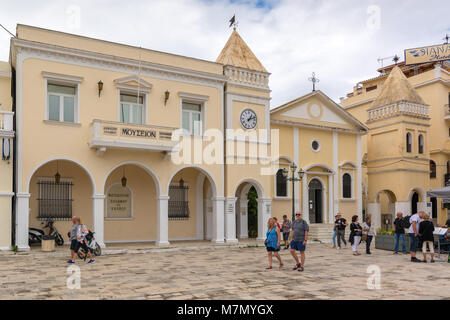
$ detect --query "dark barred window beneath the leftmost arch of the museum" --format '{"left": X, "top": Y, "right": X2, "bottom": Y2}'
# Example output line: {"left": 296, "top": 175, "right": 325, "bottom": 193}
{"left": 38, "top": 178, "right": 73, "bottom": 220}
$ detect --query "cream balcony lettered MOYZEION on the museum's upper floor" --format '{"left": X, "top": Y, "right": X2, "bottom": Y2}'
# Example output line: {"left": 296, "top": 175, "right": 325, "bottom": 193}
{"left": 89, "top": 120, "right": 177, "bottom": 155}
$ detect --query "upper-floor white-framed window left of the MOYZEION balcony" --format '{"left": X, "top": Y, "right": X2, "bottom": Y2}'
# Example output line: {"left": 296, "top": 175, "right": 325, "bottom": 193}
{"left": 47, "top": 83, "right": 76, "bottom": 122}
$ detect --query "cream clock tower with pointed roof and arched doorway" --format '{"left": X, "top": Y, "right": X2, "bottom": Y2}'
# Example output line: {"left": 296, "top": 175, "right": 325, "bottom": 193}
{"left": 216, "top": 28, "right": 271, "bottom": 242}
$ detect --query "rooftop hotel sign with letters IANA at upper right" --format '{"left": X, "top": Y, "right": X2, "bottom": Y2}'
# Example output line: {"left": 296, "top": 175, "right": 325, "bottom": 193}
{"left": 405, "top": 43, "right": 450, "bottom": 65}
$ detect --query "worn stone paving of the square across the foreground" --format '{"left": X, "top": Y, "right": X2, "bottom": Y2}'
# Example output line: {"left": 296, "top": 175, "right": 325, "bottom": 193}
{"left": 0, "top": 244, "right": 450, "bottom": 299}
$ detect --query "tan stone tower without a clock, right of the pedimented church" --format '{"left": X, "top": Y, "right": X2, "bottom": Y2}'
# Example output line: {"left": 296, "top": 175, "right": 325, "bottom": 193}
{"left": 366, "top": 66, "right": 430, "bottom": 227}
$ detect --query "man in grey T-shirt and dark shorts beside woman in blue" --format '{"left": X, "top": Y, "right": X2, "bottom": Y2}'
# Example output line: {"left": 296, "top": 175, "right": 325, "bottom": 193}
{"left": 290, "top": 212, "right": 309, "bottom": 271}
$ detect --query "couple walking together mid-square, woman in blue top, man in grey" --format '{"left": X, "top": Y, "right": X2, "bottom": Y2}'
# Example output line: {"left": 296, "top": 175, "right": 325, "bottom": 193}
{"left": 265, "top": 212, "right": 309, "bottom": 272}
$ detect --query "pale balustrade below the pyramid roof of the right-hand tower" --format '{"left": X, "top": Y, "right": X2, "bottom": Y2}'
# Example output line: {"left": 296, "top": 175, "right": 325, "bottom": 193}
{"left": 367, "top": 101, "right": 429, "bottom": 122}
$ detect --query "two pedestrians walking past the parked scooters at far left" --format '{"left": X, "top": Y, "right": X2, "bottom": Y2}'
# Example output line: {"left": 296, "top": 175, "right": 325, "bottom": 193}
{"left": 67, "top": 216, "right": 95, "bottom": 264}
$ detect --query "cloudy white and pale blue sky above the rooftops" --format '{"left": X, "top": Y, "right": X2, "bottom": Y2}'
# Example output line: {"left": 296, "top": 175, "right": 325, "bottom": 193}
{"left": 0, "top": 0, "right": 450, "bottom": 107}
